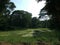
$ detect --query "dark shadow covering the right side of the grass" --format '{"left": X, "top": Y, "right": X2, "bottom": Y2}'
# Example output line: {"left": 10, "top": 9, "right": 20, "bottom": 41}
{"left": 33, "top": 30, "right": 60, "bottom": 45}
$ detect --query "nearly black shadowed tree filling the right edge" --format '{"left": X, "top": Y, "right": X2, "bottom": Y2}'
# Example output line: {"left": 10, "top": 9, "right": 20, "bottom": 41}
{"left": 38, "top": 0, "right": 60, "bottom": 29}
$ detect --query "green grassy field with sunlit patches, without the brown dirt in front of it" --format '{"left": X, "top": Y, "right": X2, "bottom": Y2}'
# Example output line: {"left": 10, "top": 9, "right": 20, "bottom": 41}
{"left": 0, "top": 28, "right": 58, "bottom": 43}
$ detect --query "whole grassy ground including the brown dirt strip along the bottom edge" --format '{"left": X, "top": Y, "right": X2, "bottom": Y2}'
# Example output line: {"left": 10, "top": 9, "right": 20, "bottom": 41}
{"left": 0, "top": 28, "right": 59, "bottom": 45}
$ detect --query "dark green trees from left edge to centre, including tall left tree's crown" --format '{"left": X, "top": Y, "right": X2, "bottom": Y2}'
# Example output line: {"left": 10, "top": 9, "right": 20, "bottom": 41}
{"left": 0, "top": 0, "right": 48, "bottom": 30}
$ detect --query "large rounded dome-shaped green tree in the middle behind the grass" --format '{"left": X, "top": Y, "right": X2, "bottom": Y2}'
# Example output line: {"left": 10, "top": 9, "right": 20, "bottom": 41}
{"left": 11, "top": 10, "right": 32, "bottom": 28}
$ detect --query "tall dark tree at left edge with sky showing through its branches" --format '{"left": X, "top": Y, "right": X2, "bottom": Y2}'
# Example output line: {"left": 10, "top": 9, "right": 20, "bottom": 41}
{"left": 0, "top": 0, "right": 15, "bottom": 30}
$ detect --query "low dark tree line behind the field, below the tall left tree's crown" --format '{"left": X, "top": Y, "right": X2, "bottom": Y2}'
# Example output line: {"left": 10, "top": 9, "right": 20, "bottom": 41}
{"left": 0, "top": 10, "right": 50, "bottom": 30}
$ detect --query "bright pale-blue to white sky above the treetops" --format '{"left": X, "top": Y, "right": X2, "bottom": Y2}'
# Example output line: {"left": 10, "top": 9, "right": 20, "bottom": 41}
{"left": 11, "top": 0, "right": 45, "bottom": 17}
